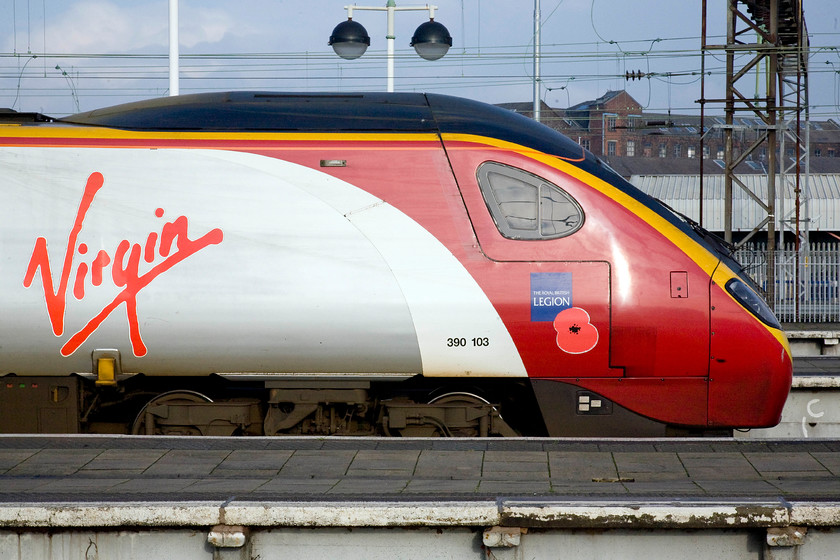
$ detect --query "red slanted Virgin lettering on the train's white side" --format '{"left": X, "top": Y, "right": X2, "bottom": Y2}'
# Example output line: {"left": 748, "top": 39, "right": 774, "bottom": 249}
{"left": 23, "top": 173, "right": 223, "bottom": 356}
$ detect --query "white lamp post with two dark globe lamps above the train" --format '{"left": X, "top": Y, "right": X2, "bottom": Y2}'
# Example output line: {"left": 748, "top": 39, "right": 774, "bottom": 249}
{"left": 329, "top": 0, "right": 452, "bottom": 92}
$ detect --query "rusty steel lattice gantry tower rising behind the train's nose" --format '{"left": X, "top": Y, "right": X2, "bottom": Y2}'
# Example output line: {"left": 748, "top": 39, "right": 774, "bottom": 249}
{"left": 700, "top": 0, "right": 809, "bottom": 310}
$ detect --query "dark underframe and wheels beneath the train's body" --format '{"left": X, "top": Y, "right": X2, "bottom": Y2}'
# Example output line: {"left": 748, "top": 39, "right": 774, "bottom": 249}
{"left": 0, "top": 375, "right": 721, "bottom": 437}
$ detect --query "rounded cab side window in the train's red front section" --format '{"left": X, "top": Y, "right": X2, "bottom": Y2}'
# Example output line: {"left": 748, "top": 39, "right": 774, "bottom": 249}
{"left": 477, "top": 162, "right": 583, "bottom": 239}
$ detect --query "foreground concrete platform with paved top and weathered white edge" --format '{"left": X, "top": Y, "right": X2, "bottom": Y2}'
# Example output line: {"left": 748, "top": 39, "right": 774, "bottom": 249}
{"left": 0, "top": 435, "right": 840, "bottom": 560}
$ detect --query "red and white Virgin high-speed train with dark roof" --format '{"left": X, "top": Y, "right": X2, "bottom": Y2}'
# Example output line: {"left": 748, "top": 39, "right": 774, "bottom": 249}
{"left": 0, "top": 92, "right": 792, "bottom": 436}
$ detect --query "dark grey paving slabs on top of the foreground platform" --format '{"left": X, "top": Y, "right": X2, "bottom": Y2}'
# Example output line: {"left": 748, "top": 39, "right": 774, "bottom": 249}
{"left": 0, "top": 435, "right": 840, "bottom": 505}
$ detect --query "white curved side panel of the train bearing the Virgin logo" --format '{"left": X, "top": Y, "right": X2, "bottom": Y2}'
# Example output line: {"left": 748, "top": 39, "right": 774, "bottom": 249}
{"left": 0, "top": 147, "right": 525, "bottom": 376}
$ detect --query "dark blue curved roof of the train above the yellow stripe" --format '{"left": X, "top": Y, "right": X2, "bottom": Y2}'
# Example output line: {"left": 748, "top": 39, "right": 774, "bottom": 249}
{"left": 57, "top": 91, "right": 584, "bottom": 160}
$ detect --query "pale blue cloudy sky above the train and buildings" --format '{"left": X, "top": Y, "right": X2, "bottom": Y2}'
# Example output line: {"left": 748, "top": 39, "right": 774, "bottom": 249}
{"left": 0, "top": 0, "right": 840, "bottom": 121}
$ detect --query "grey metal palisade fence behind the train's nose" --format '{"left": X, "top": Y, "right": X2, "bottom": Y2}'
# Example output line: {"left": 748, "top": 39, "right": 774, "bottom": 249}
{"left": 735, "top": 243, "right": 840, "bottom": 323}
